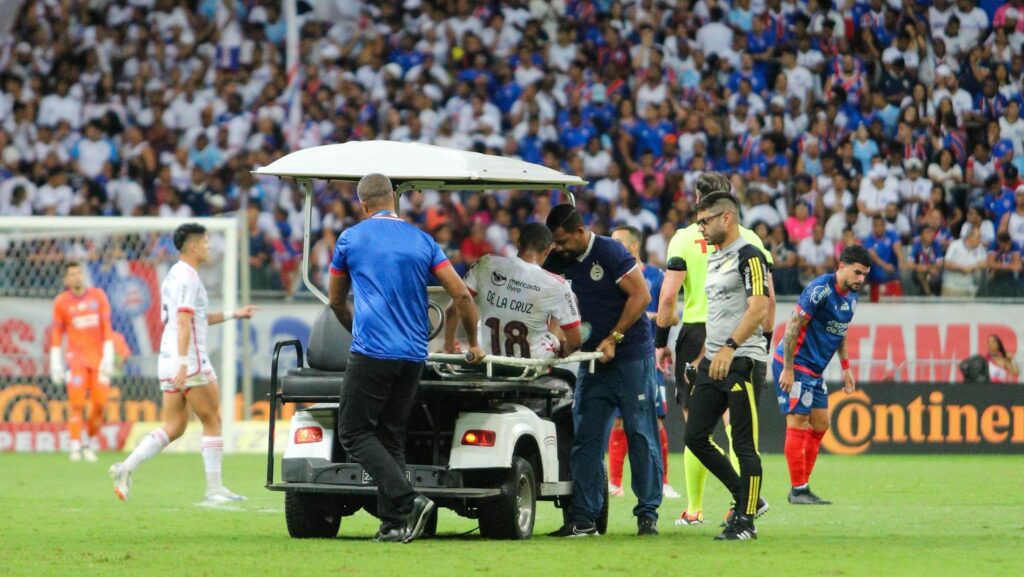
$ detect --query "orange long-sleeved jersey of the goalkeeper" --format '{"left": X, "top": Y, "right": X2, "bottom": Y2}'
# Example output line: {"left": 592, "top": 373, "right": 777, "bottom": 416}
{"left": 50, "top": 288, "right": 113, "bottom": 368}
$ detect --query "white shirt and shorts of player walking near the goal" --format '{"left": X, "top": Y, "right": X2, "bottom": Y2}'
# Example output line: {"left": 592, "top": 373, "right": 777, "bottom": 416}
{"left": 157, "top": 260, "right": 210, "bottom": 380}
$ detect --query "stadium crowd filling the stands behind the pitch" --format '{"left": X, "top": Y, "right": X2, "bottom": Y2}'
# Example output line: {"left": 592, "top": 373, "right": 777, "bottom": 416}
{"left": 0, "top": 0, "right": 1024, "bottom": 298}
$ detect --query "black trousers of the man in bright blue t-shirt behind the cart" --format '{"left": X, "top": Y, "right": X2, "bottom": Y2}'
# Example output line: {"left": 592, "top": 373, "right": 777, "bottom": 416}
{"left": 338, "top": 353, "right": 423, "bottom": 529}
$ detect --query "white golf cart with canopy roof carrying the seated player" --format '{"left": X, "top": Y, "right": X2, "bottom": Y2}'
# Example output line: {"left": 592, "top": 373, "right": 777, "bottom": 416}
{"left": 255, "top": 140, "right": 607, "bottom": 539}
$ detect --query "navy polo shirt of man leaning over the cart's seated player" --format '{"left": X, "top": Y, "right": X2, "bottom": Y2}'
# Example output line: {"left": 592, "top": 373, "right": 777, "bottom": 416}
{"left": 544, "top": 234, "right": 654, "bottom": 361}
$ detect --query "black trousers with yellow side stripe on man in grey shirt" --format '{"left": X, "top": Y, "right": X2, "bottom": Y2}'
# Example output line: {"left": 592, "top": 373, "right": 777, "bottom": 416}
{"left": 686, "top": 357, "right": 761, "bottom": 517}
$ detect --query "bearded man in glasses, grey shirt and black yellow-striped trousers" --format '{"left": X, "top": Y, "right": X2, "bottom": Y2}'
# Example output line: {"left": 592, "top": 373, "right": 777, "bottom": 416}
{"left": 686, "top": 193, "right": 768, "bottom": 540}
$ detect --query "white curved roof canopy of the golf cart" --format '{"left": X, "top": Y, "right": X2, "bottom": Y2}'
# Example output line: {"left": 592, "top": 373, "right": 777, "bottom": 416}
{"left": 254, "top": 140, "right": 587, "bottom": 189}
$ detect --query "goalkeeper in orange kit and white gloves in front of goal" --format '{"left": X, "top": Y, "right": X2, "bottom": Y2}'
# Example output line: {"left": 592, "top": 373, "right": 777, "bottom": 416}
{"left": 50, "top": 262, "right": 115, "bottom": 462}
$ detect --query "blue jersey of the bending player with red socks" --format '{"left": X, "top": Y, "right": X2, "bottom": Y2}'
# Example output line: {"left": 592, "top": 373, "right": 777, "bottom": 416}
{"left": 775, "top": 274, "right": 857, "bottom": 377}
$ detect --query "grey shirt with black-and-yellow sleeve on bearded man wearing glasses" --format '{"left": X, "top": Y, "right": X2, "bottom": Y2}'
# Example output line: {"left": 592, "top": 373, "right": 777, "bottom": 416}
{"left": 705, "top": 238, "right": 768, "bottom": 363}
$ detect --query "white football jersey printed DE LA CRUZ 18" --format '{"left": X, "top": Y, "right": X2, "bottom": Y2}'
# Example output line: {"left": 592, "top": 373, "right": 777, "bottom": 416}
{"left": 466, "top": 254, "right": 580, "bottom": 359}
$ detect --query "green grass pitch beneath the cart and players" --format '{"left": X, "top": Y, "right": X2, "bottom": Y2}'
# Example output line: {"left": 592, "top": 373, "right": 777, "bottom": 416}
{"left": 0, "top": 454, "right": 1024, "bottom": 577}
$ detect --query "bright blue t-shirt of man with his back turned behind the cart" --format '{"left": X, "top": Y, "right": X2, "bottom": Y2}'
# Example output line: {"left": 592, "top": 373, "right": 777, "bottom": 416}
{"left": 331, "top": 211, "right": 450, "bottom": 362}
